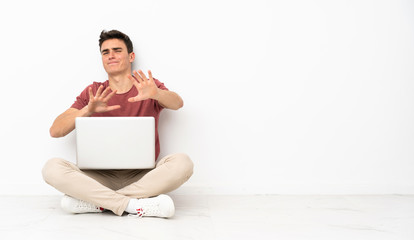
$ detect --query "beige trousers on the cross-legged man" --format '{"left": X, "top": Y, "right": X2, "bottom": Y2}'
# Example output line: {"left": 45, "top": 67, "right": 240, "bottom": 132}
{"left": 42, "top": 153, "right": 193, "bottom": 216}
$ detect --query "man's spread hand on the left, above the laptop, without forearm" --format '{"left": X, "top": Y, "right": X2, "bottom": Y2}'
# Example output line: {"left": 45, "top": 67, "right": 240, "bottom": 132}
{"left": 88, "top": 85, "right": 121, "bottom": 114}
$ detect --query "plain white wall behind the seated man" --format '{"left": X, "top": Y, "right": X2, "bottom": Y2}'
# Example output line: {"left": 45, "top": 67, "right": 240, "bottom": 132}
{"left": 0, "top": 0, "right": 414, "bottom": 194}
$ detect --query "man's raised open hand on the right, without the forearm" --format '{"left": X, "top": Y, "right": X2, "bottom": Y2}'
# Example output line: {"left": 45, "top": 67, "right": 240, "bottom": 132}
{"left": 128, "top": 70, "right": 158, "bottom": 102}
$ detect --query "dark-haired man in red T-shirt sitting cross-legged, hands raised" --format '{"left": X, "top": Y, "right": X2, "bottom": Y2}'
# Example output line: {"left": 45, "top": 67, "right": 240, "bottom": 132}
{"left": 42, "top": 30, "right": 193, "bottom": 217}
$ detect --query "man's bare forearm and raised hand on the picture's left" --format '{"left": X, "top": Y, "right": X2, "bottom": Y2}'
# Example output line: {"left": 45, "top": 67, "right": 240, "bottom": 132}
{"left": 49, "top": 86, "right": 121, "bottom": 138}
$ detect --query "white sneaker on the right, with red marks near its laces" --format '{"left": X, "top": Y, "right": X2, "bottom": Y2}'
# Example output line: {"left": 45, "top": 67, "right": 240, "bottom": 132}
{"left": 128, "top": 194, "right": 175, "bottom": 218}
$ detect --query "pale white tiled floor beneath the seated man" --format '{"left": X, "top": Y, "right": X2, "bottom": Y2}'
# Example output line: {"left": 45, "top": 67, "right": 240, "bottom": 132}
{"left": 0, "top": 195, "right": 414, "bottom": 240}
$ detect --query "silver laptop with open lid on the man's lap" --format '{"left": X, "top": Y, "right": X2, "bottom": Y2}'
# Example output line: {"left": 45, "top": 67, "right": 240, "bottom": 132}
{"left": 75, "top": 117, "right": 155, "bottom": 169}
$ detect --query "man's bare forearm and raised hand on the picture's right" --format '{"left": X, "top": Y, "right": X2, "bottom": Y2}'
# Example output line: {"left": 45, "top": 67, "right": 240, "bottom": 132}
{"left": 128, "top": 70, "right": 184, "bottom": 110}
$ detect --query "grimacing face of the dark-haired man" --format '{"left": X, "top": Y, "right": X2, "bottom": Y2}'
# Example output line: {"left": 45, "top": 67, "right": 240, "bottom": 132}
{"left": 101, "top": 39, "right": 135, "bottom": 75}
